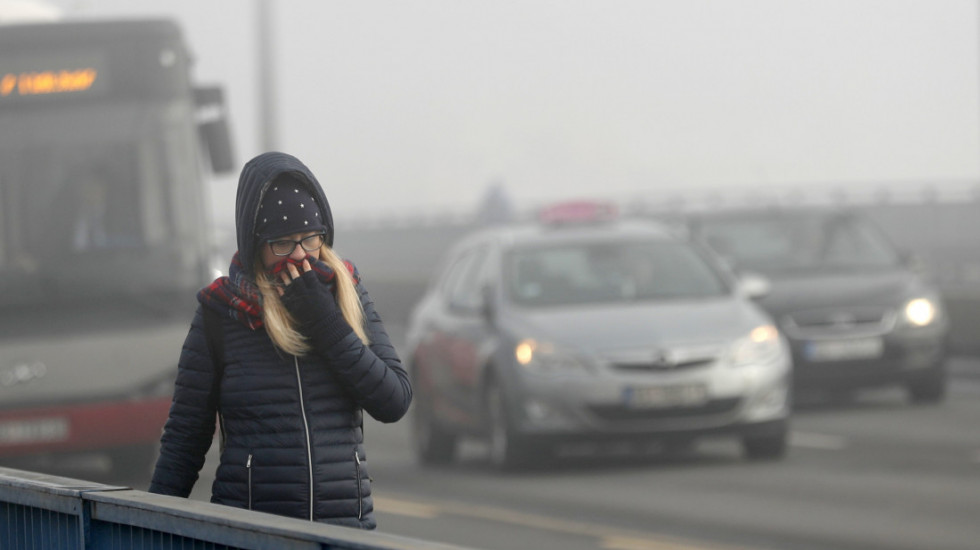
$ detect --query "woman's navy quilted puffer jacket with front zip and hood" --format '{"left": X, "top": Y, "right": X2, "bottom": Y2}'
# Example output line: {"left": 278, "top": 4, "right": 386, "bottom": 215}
{"left": 150, "top": 153, "right": 412, "bottom": 529}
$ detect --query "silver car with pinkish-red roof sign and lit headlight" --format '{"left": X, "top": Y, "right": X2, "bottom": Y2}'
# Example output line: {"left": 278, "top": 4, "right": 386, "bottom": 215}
{"left": 407, "top": 215, "right": 791, "bottom": 467}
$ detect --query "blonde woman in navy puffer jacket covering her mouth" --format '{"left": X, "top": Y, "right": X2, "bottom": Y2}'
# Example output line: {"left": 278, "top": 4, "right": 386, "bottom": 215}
{"left": 150, "top": 153, "right": 412, "bottom": 529}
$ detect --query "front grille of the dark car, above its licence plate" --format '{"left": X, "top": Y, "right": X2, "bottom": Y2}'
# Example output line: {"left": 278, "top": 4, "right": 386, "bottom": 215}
{"left": 782, "top": 306, "right": 895, "bottom": 340}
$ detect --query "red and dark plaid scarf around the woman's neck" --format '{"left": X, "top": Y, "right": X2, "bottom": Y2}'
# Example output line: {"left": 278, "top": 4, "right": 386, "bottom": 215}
{"left": 197, "top": 252, "right": 359, "bottom": 330}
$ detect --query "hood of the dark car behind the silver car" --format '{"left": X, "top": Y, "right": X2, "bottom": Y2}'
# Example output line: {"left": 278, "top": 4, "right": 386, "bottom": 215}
{"left": 758, "top": 270, "right": 927, "bottom": 318}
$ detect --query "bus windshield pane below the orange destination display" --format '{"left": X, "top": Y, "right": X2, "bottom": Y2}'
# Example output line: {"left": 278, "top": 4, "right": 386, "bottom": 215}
{"left": 0, "top": 100, "right": 207, "bottom": 305}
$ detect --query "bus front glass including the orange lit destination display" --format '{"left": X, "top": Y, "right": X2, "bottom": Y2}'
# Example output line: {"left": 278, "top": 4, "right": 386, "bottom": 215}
{"left": 0, "top": 22, "right": 211, "bottom": 307}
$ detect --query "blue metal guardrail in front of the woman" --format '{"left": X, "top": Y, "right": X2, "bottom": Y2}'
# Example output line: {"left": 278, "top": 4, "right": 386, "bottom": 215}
{"left": 0, "top": 468, "right": 474, "bottom": 550}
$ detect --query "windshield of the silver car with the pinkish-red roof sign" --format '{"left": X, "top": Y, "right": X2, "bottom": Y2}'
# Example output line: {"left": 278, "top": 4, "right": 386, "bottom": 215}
{"left": 505, "top": 241, "right": 728, "bottom": 307}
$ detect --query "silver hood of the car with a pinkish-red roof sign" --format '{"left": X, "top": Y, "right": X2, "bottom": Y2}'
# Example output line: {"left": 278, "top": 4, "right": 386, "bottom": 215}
{"left": 507, "top": 298, "right": 770, "bottom": 353}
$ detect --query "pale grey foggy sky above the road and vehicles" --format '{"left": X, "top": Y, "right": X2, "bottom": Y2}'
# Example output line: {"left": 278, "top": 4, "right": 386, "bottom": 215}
{"left": 42, "top": 0, "right": 980, "bottom": 224}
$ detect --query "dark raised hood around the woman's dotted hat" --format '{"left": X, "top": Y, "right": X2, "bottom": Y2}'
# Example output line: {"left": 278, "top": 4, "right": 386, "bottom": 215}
{"left": 235, "top": 151, "right": 333, "bottom": 276}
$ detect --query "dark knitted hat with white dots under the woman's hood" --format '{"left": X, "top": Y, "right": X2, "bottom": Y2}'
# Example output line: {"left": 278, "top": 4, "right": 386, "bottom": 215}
{"left": 255, "top": 174, "right": 326, "bottom": 241}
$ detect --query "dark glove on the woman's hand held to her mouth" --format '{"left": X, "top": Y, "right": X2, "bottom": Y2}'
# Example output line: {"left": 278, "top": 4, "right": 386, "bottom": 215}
{"left": 282, "top": 271, "right": 353, "bottom": 347}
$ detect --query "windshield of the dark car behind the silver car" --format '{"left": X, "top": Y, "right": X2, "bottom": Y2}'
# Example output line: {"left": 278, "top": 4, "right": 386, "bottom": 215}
{"left": 699, "top": 215, "right": 899, "bottom": 273}
